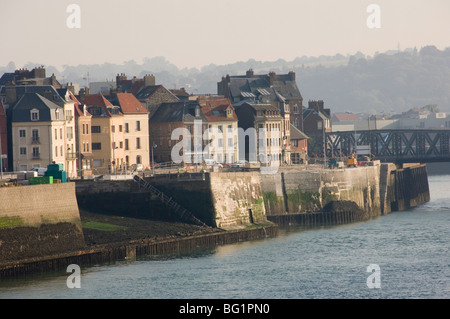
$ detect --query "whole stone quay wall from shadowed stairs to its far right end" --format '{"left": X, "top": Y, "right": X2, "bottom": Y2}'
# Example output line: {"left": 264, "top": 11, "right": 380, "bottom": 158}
{"left": 77, "top": 161, "right": 429, "bottom": 228}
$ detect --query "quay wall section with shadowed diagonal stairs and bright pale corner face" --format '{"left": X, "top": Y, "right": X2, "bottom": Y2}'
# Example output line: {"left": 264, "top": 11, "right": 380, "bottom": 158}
{"left": 76, "top": 172, "right": 267, "bottom": 228}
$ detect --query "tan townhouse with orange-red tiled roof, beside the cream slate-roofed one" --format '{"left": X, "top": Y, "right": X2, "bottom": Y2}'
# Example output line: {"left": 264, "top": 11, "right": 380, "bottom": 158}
{"left": 82, "top": 93, "right": 150, "bottom": 175}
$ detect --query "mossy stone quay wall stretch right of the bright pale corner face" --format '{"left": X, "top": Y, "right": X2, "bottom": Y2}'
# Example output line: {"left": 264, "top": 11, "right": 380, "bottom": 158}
{"left": 261, "top": 165, "right": 381, "bottom": 216}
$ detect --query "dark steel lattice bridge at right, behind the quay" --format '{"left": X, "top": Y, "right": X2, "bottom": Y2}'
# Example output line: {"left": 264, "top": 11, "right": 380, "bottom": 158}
{"left": 322, "top": 129, "right": 450, "bottom": 163}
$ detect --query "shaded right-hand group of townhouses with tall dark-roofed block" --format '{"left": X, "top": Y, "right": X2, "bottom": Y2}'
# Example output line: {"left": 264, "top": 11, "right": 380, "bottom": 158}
{"left": 111, "top": 70, "right": 308, "bottom": 163}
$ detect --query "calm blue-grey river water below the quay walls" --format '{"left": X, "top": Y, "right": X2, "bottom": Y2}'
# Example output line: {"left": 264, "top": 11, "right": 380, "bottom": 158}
{"left": 0, "top": 164, "right": 450, "bottom": 299}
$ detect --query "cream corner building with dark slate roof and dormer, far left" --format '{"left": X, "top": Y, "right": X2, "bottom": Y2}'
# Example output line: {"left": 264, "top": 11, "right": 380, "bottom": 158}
{"left": 8, "top": 86, "right": 77, "bottom": 177}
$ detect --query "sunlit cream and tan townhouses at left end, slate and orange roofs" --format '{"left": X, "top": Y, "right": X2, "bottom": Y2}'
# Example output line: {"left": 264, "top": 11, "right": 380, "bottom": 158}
{"left": 0, "top": 78, "right": 150, "bottom": 178}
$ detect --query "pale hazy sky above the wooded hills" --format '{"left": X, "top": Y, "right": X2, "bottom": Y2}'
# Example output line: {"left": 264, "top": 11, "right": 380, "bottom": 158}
{"left": 0, "top": 0, "right": 450, "bottom": 68}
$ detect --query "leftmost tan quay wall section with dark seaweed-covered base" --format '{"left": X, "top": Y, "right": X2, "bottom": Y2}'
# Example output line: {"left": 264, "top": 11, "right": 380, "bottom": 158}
{"left": 0, "top": 183, "right": 85, "bottom": 262}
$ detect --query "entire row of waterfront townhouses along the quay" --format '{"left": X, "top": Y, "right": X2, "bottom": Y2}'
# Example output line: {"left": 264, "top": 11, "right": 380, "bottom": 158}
{"left": 0, "top": 69, "right": 324, "bottom": 177}
